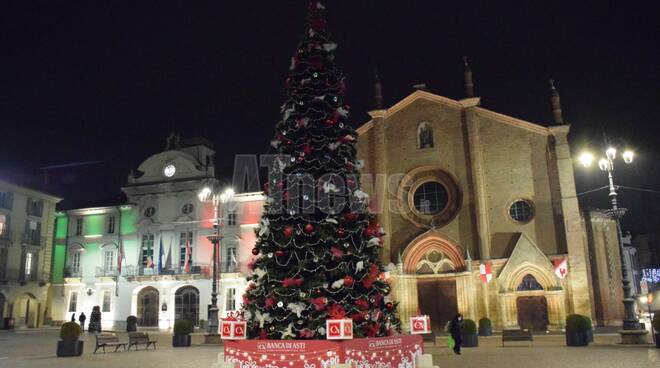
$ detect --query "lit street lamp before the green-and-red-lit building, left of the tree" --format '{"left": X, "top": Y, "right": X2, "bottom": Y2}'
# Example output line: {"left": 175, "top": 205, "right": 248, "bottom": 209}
{"left": 198, "top": 187, "right": 234, "bottom": 343}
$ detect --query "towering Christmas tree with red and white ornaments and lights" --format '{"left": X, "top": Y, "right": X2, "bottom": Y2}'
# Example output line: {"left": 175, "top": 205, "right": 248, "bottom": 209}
{"left": 243, "top": 2, "right": 401, "bottom": 339}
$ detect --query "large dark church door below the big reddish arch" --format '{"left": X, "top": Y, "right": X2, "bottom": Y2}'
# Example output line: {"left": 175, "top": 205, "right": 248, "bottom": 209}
{"left": 417, "top": 279, "right": 458, "bottom": 332}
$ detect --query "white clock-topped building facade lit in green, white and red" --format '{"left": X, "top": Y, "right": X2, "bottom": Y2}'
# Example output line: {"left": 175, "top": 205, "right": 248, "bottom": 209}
{"left": 51, "top": 138, "right": 263, "bottom": 328}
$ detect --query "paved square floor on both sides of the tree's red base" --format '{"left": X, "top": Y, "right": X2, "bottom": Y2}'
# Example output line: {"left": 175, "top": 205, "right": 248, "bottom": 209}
{"left": 0, "top": 330, "right": 660, "bottom": 368}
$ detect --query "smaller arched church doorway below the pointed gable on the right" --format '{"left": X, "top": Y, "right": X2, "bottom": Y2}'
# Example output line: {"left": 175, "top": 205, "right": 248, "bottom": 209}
{"left": 516, "top": 274, "right": 549, "bottom": 331}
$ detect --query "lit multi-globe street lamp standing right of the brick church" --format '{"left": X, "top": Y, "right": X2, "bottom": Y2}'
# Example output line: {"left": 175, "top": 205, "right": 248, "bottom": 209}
{"left": 580, "top": 146, "right": 640, "bottom": 330}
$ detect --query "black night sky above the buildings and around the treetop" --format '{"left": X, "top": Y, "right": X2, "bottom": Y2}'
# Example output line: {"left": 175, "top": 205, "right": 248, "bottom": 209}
{"left": 0, "top": 0, "right": 660, "bottom": 237}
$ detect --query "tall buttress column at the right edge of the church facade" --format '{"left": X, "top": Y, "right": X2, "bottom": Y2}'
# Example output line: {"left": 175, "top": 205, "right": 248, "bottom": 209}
{"left": 550, "top": 125, "right": 592, "bottom": 317}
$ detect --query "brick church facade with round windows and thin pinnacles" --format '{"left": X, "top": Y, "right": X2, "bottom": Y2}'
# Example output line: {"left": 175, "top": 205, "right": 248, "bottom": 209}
{"left": 358, "top": 73, "right": 623, "bottom": 331}
